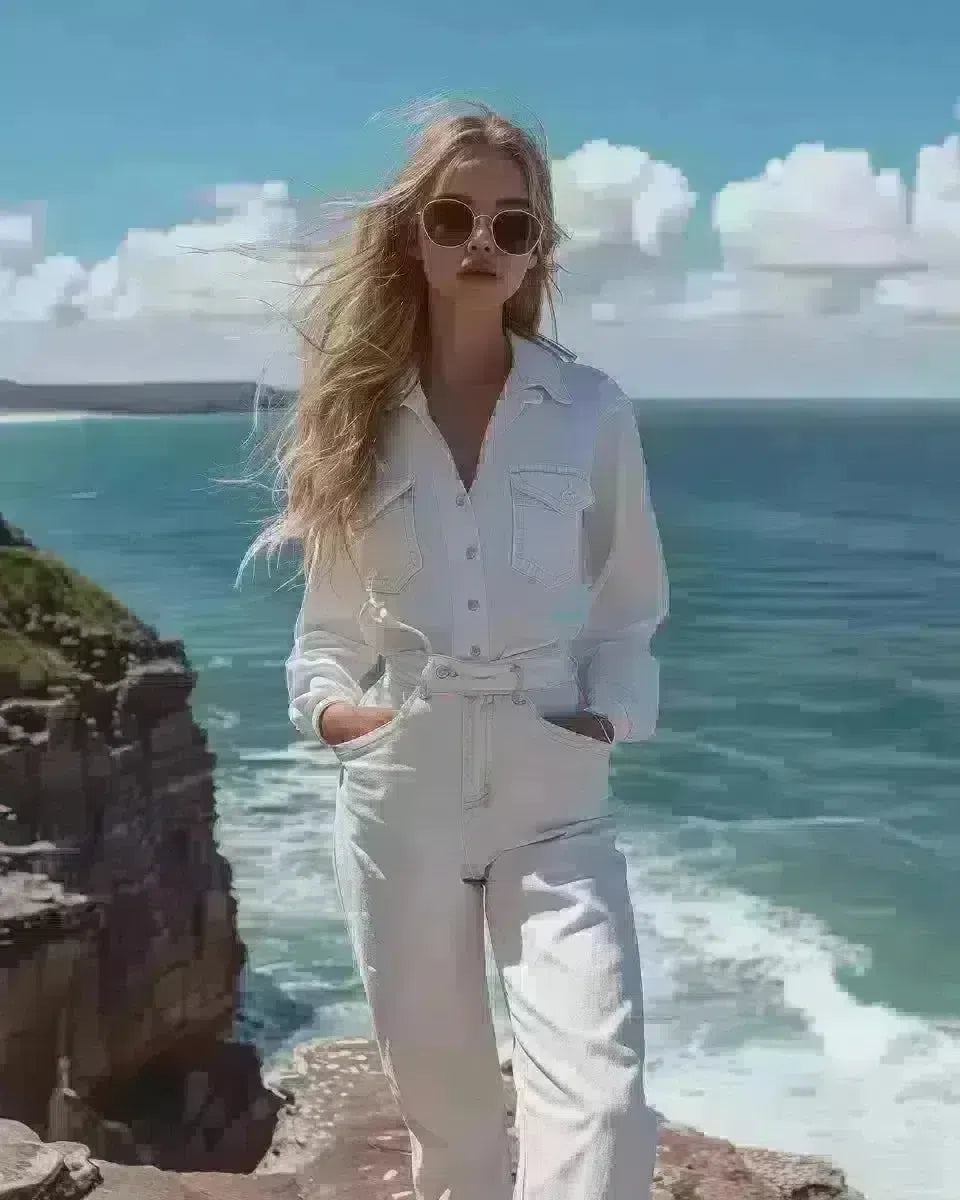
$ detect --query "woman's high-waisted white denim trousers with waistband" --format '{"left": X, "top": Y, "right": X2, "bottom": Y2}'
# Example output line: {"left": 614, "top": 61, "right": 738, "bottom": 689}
{"left": 334, "top": 654, "right": 656, "bottom": 1200}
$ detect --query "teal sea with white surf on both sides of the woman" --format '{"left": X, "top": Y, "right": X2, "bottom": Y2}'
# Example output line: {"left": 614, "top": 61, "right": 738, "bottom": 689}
{"left": 0, "top": 406, "right": 960, "bottom": 1200}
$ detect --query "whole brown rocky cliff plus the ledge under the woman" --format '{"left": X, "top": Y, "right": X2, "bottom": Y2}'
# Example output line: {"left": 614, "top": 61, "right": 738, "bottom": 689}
{"left": 0, "top": 518, "right": 862, "bottom": 1200}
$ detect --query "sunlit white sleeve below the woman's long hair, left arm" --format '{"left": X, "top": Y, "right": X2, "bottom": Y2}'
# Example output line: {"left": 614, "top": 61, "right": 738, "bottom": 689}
{"left": 287, "top": 558, "right": 377, "bottom": 742}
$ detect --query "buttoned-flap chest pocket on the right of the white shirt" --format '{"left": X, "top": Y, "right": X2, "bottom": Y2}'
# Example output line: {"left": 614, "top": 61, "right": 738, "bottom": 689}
{"left": 510, "top": 467, "right": 594, "bottom": 587}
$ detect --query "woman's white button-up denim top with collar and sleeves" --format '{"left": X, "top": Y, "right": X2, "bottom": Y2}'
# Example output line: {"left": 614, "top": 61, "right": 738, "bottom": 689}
{"left": 287, "top": 335, "right": 668, "bottom": 742}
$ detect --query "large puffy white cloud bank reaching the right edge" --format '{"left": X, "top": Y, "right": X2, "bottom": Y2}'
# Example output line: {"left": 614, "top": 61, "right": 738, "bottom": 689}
{"left": 680, "top": 137, "right": 960, "bottom": 319}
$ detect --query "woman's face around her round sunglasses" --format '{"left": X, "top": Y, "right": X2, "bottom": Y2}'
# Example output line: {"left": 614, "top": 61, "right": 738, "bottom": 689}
{"left": 414, "top": 149, "right": 538, "bottom": 308}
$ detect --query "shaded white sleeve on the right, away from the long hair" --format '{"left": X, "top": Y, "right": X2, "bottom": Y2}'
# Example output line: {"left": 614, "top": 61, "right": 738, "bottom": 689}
{"left": 572, "top": 390, "right": 668, "bottom": 742}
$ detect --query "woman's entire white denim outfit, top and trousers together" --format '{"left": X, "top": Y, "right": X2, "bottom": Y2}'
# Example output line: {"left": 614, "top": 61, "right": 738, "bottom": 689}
{"left": 287, "top": 336, "right": 667, "bottom": 1200}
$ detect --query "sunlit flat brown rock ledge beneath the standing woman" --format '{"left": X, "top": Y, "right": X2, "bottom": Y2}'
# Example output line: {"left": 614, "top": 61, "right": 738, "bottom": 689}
{"left": 0, "top": 1038, "right": 863, "bottom": 1200}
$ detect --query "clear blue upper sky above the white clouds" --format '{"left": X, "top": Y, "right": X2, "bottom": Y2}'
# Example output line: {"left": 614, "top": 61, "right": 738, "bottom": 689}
{"left": 0, "top": 0, "right": 960, "bottom": 260}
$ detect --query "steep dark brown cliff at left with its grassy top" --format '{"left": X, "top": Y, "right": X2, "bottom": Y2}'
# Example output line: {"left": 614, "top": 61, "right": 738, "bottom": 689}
{"left": 0, "top": 511, "right": 277, "bottom": 1165}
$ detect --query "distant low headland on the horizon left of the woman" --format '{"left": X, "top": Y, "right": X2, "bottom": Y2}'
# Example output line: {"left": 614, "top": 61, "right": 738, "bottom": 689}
{"left": 0, "top": 379, "right": 295, "bottom": 415}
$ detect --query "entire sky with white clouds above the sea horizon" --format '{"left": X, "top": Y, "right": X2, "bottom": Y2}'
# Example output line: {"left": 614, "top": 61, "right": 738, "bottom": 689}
{"left": 0, "top": 0, "right": 960, "bottom": 400}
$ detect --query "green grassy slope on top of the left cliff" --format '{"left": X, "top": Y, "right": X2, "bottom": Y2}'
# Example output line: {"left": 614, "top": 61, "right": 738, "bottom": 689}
{"left": 0, "top": 545, "right": 152, "bottom": 700}
